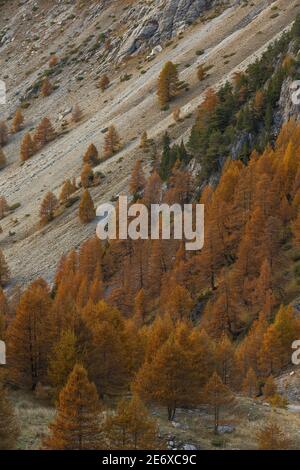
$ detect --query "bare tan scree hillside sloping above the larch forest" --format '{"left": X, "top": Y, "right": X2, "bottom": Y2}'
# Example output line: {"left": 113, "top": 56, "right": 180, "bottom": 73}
{"left": 0, "top": 1, "right": 298, "bottom": 284}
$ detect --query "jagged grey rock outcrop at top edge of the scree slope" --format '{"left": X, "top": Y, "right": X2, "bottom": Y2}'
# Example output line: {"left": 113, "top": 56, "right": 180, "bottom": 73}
{"left": 119, "top": 0, "right": 233, "bottom": 57}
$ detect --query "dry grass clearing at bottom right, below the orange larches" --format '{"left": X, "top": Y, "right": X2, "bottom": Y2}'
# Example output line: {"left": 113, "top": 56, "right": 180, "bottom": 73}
{"left": 155, "top": 397, "right": 300, "bottom": 450}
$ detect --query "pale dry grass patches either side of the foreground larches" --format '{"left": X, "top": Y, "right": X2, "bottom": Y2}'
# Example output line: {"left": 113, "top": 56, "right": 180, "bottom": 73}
{"left": 12, "top": 391, "right": 300, "bottom": 450}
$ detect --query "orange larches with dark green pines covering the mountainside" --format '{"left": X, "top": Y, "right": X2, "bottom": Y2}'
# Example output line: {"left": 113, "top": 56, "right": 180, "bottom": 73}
{"left": 0, "top": 28, "right": 300, "bottom": 450}
